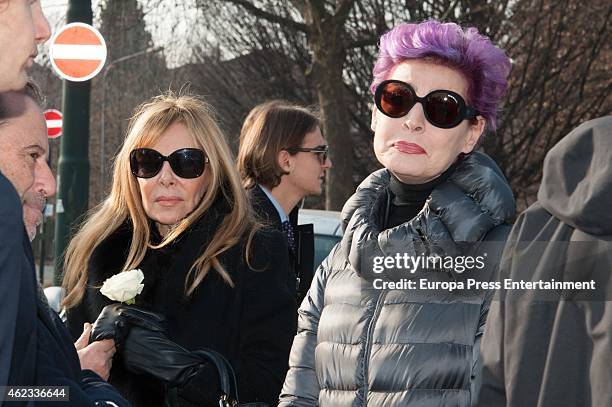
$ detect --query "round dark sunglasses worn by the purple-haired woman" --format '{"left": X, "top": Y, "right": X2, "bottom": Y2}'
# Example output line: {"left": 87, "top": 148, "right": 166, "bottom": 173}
{"left": 374, "top": 79, "right": 478, "bottom": 129}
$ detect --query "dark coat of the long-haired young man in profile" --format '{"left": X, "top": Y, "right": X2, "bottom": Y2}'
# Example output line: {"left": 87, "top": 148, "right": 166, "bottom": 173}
{"left": 249, "top": 185, "right": 314, "bottom": 304}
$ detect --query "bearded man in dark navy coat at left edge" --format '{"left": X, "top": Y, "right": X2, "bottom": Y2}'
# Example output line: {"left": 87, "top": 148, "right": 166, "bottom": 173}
{"left": 0, "top": 82, "right": 125, "bottom": 405}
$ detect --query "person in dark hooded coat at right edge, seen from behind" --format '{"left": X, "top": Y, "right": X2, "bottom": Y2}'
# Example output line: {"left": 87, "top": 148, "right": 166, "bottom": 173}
{"left": 479, "top": 116, "right": 612, "bottom": 407}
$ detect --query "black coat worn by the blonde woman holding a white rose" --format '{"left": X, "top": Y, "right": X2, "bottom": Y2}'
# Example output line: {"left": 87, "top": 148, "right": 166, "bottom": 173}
{"left": 68, "top": 196, "right": 295, "bottom": 407}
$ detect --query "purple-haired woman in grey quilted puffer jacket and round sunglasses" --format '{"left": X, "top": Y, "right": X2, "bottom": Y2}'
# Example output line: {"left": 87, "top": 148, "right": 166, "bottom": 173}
{"left": 280, "top": 21, "right": 514, "bottom": 407}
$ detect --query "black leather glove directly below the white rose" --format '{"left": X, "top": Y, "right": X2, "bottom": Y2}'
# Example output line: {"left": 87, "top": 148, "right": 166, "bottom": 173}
{"left": 89, "top": 303, "right": 165, "bottom": 349}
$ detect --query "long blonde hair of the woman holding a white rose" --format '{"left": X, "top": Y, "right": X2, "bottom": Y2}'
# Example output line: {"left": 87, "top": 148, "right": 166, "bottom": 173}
{"left": 62, "top": 92, "right": 258, "bottom": 308}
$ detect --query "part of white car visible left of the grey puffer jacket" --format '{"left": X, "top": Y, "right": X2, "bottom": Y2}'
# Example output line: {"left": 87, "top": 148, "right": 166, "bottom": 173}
{"left": 298, "top": 209, "right": 342, "bottom": 270}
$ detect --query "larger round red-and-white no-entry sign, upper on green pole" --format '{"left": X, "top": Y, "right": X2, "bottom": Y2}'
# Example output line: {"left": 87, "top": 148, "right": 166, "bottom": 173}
{"left": 49, "top": 23, "right": 106, "bottom": 82}
